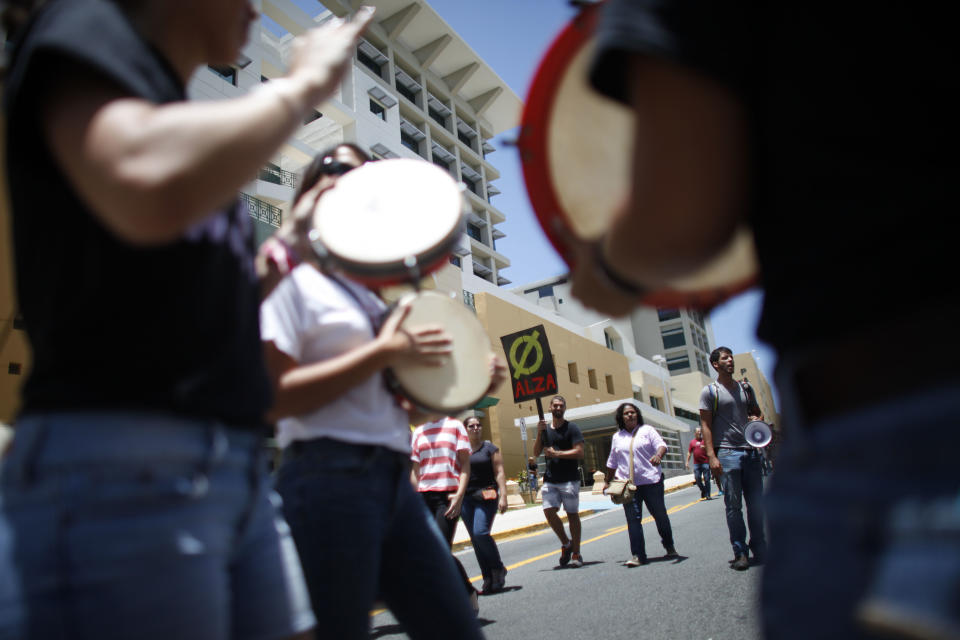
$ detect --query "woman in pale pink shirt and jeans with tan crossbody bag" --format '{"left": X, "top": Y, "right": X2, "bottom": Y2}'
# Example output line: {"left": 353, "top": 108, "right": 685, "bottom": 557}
{"left": 603, "top": 402, "right": 679, "bottom": 567}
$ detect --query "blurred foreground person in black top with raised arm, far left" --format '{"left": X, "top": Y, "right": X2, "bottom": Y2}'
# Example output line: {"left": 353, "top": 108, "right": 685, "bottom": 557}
{"left": 0, "top": 0, "right": 373, "bottom": 639}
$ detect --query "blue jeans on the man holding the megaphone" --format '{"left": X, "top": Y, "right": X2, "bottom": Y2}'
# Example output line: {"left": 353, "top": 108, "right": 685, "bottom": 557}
{"left": 717, "top": 449, "right": 767, "bottom": 559}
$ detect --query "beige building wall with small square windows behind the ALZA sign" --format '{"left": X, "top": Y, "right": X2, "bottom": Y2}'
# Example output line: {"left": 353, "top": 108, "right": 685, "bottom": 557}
{"left": 474, "top": 293, "right": 633, "bottom": 477}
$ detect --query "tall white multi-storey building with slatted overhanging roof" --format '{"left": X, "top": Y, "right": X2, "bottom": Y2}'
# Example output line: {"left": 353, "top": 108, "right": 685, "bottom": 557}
{"left": 189, "top": 0, "right": 522, "bottom": 290}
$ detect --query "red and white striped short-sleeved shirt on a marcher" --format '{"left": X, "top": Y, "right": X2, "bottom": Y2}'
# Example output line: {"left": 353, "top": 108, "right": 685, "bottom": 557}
{"left": 410, "top": 418, "right": 470, "bottom": 492}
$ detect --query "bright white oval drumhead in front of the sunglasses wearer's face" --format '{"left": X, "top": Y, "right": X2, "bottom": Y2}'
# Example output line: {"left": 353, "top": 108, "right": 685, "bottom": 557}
{"left": 314, "top": 158, "right": 464, "bottom": 270}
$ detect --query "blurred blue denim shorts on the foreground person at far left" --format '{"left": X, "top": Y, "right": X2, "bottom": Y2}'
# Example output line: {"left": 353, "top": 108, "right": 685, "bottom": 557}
{"left": 0, "top": 412, "right": 314, "bottom": 640}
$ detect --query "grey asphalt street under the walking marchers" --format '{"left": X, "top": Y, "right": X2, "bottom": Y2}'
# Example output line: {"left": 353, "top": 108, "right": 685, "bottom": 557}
{"left": 371, "top": 487, "right": 762, "bottom": 640}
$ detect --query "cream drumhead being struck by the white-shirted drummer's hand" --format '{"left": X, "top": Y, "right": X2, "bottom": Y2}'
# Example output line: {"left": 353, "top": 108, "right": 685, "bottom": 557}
{"left": 392, "top": 291, "right": 493, "bottom": 414}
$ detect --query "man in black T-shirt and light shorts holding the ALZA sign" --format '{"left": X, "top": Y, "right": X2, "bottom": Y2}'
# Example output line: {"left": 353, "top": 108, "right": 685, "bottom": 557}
{"left": 533, "top": 396, "right": 583, "bottom": 567}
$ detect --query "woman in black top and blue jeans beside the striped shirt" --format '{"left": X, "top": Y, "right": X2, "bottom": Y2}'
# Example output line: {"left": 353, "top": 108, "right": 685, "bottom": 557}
{"left": 460, "top": 417, "right": 507, "bottom": 594}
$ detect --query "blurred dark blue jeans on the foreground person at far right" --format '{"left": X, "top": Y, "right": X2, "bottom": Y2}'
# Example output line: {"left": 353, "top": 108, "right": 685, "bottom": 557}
{"left": 761, "top": 376, "right": 960, "bottom": 640}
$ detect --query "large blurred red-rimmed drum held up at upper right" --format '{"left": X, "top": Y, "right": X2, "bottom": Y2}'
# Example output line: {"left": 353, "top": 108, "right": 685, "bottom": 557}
{"left": 518, "top": 3, "right": 757, "bottom": 308}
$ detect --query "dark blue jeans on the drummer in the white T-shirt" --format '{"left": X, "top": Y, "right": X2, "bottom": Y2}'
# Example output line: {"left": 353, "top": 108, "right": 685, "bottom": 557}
{"left": 277, "top": 438, "right": 483, "bottom": 638}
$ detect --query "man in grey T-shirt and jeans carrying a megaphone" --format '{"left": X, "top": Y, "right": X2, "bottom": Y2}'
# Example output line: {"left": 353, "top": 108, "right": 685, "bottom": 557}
{"left": 700, "top": 347, "right": 770, "bottom": 571}
